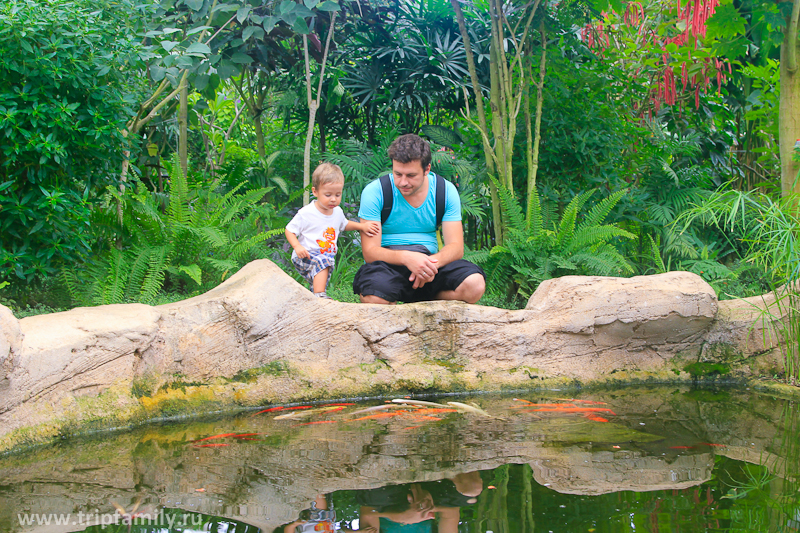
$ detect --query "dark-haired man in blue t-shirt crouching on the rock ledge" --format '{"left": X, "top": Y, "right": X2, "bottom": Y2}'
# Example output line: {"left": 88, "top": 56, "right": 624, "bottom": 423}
{"left": 353, "top": 134, "right": 486, "bottom": 304}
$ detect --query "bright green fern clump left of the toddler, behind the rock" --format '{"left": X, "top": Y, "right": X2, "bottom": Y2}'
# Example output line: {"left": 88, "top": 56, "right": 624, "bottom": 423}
{"left": 64, "top": 155, "right": 282, "bottom": 305}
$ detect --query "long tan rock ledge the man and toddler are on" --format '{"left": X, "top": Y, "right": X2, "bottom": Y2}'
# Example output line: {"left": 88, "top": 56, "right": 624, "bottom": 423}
{"left": 0, "top": 260, "right": 792, "bottom": 450}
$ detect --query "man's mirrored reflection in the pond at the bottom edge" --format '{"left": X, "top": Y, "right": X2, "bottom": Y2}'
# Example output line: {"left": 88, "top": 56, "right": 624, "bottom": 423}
{"left": 356, "top": 472, "right": 483, "bottom": 533}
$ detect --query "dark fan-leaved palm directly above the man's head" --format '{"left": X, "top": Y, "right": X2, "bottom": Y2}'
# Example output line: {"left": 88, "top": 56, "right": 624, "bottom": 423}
{"left": 339, "top": 0, "right": 476, "bottom": 146}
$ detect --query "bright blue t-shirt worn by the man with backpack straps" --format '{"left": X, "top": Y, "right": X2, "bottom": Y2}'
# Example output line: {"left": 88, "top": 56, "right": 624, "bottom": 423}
{"left": 358, "top": 172, "right": 461, "bottom": 254}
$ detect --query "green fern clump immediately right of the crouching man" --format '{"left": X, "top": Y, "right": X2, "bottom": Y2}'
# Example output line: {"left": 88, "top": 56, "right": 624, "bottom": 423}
{"left": 470, "top": 183, "right": 634, "bottom": 298}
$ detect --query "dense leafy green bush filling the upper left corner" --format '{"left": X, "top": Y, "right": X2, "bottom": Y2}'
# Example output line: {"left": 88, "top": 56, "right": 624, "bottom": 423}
{"left": 0, "top": 0, "right": 147, "bottom": 283}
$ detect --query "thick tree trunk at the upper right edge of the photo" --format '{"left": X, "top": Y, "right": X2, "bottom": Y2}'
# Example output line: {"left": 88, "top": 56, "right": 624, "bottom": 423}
{"left": 778, "top": 0, "right": 800, "bottom": 196}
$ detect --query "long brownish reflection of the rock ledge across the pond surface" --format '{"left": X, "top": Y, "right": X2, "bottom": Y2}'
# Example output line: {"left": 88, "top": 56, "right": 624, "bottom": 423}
{"left": 0, "top": 389, "right": 785, "bottom": 531}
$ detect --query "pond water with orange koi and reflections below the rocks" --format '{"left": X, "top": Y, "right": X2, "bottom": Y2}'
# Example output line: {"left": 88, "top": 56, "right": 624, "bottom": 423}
{"left": 0, "top": 387, "right": 800, "bottom": 533}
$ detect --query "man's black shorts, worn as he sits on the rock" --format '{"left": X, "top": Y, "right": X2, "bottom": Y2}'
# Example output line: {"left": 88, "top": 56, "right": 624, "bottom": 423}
{"left": 353, "top": 255, "right": 486, "bottom": 303}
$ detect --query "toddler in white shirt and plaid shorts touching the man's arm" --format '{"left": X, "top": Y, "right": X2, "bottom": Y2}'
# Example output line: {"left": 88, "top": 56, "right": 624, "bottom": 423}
{"left": 286, "top": 163, "right": 381, "bottom": 298}
